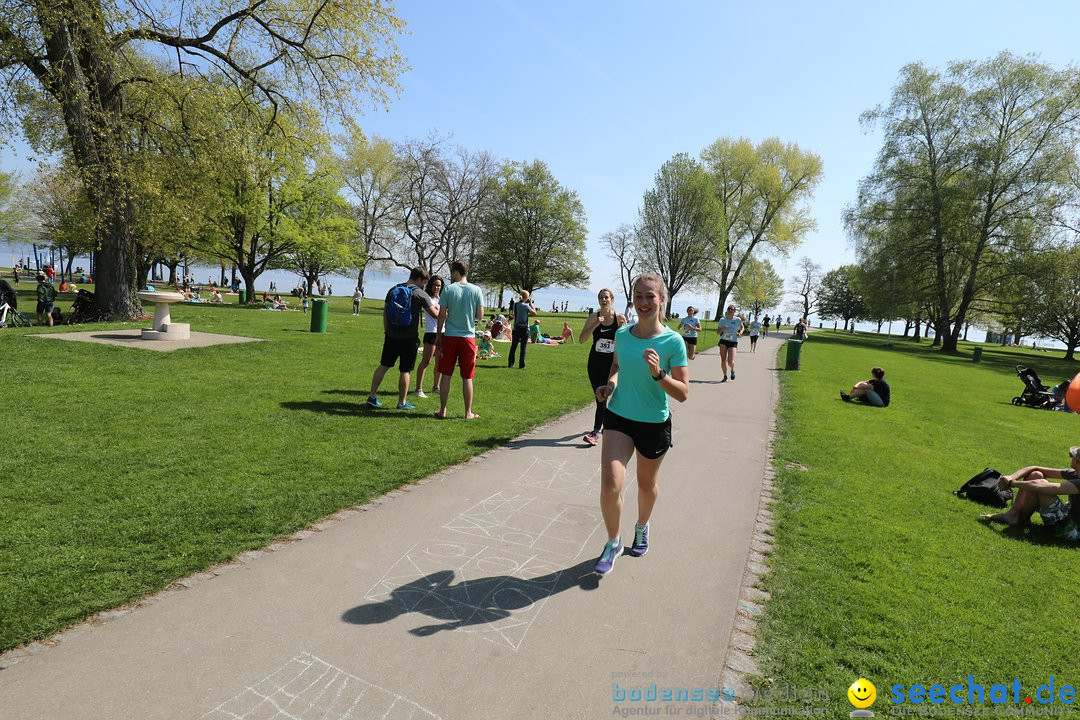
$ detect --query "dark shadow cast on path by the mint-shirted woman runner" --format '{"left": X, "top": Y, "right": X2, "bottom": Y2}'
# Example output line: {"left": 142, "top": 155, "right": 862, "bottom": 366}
{"left": 341, "top": 560, "right": 599, "bottom": 637}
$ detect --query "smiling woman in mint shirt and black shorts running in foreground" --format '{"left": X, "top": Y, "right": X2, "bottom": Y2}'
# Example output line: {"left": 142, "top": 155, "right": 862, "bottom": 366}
{"left": 595, "top": 273, "right": 690, "bottom": 575}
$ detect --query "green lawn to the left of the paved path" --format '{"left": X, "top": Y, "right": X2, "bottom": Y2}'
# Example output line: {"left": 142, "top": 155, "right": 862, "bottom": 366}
{"left": 0, "top": 283, "right": 592, "bottom": 649}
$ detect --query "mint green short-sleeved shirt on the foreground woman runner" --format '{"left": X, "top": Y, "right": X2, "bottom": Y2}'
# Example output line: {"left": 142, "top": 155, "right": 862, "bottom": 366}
{"left": 608, "top": 324, "right": 687, "bottom": 422}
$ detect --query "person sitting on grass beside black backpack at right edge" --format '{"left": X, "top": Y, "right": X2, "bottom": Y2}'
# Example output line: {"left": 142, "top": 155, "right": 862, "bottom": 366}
{"left": 980, "top": 445, "right": 1080, "bottom": 540}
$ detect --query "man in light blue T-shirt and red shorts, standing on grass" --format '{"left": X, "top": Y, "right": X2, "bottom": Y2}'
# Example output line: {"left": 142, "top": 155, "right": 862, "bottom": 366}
{"left": 435, "top": 260, "right": 484, "bottom": 420}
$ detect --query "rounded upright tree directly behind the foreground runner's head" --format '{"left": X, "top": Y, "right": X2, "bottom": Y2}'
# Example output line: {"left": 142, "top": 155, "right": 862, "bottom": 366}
{"left": 635, "top": 152, "right": 717, "bottom": 315}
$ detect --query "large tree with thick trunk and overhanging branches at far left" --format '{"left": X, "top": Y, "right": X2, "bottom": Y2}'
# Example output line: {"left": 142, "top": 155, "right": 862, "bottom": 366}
{"left": 0, "top": 0, "right": 404, "bottom": 317}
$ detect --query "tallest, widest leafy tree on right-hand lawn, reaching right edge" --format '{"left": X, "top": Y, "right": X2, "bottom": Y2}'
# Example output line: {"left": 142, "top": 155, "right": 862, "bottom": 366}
{"left": 847, "top": 53, "right": 1080, "bottom": 352}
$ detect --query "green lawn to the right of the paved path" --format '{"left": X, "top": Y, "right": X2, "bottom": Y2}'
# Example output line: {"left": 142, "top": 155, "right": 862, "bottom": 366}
{"left": 758, "top": 331, "right": 1080, "bottom": 717}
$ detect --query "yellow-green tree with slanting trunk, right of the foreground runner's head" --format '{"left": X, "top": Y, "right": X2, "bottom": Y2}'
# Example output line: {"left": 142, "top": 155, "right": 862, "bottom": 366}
{"left": 701, "top": 138, "right": 822, "bottom": 317}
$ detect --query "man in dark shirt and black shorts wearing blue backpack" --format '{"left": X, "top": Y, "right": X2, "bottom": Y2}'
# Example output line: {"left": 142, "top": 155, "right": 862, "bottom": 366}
{"left": 367, "top": 268, "right": 438, "bottom": 410}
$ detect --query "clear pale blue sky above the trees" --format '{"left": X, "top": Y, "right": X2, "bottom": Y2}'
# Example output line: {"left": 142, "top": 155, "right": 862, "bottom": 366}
{"left": 0, "top": 0, "right": 1080, "bottom": 308}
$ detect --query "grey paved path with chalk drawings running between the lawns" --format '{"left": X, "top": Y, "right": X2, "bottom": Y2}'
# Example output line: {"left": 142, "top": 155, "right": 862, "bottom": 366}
{"left": 0, "top": 335, "right": 783, "bottom": 720}
